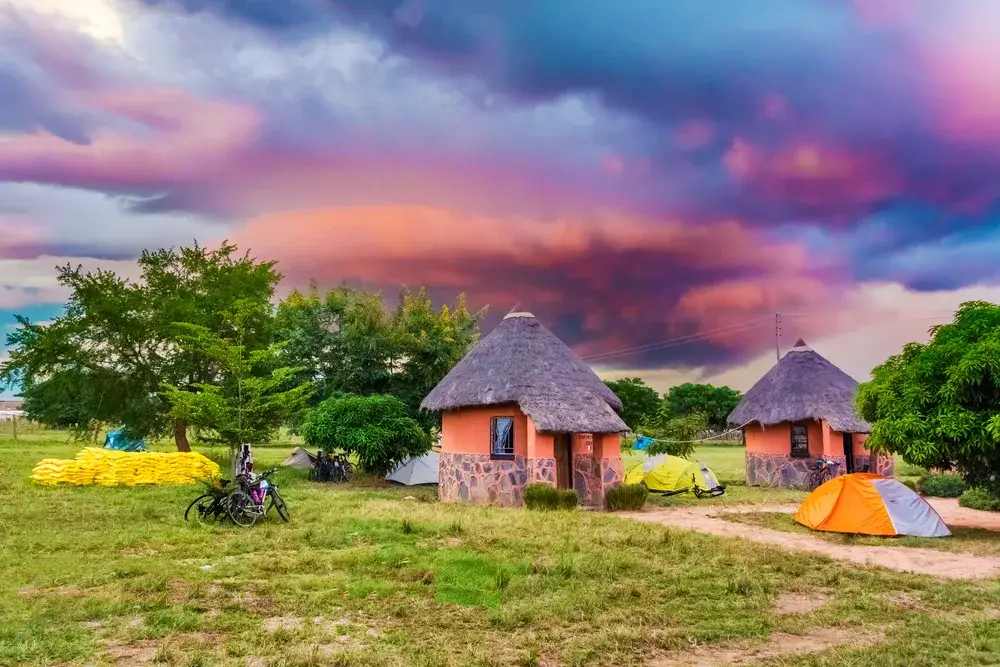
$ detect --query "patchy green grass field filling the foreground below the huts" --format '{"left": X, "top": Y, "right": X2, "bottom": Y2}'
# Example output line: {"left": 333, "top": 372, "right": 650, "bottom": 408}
{"left": 0, "top": 434, "right": 1000, "bottom": 667}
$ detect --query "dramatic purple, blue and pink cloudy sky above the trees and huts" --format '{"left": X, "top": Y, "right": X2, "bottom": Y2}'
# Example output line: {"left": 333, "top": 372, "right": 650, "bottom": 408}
{"left": 0, "top": 0, "right": 1000, "bottom": 396}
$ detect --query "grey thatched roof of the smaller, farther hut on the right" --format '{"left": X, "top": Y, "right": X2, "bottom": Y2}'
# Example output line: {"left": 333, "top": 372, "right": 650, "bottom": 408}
{"left": 729, "top": 339, "right": 872, "bottom": 433}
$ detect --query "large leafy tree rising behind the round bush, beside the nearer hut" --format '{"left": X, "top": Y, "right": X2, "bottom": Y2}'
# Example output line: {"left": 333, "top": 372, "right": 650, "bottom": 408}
{"left": 275, "top": 285, "right": 485, "bottom": 428}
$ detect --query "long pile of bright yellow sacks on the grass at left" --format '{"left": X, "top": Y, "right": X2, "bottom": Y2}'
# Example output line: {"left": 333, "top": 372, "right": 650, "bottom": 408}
{"left": 31, "top": 447, "right": 219, "bottom": 486}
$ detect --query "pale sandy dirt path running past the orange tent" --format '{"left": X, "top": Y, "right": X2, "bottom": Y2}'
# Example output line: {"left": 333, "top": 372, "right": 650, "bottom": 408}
{"left": 621, "top": 498, "right": 1000, "bottom": 579}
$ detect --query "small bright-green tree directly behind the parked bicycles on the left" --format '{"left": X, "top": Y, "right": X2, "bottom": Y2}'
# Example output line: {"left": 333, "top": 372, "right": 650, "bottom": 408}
{"left": 163, "top": 302, "right": 312, "bottom": 450}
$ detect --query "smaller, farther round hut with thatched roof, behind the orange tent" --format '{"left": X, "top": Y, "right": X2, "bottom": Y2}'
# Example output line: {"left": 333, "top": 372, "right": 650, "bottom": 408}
{"left": 729, "top": 339, "right": 892, "bottom": 489}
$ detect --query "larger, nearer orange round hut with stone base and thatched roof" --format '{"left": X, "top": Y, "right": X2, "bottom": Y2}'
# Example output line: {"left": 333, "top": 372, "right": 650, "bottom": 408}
{"left": 421, "top": 313, "right": 628, "bottom": 506}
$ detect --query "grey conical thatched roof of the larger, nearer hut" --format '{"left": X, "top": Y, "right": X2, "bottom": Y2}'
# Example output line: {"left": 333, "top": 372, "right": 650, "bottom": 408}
{"left": 420, "top": 313, "right": 628, "bottom": 433}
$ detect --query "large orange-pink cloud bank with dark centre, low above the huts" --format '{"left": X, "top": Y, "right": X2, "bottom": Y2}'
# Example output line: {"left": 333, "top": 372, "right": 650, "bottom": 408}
{"left": 236, "top": 206, "right": 835, "bottom": 368}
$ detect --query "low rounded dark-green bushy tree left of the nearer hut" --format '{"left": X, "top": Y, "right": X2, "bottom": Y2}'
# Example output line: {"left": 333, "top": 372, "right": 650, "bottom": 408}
{"left": 302, "top": 394, "right": 431, "bottom": 477}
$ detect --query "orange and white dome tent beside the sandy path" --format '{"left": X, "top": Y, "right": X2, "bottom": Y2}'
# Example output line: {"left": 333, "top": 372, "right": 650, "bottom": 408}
{"left": 795, "top": 473, "right": 951, "bottom": 537}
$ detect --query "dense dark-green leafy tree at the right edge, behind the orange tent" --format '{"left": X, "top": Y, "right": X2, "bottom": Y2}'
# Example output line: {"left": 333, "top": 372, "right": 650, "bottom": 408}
{"left": 856, "top": 301, "right": 1000, "bottom": 497}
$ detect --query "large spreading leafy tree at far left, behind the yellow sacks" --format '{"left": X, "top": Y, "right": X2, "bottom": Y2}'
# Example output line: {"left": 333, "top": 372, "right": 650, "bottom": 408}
{"left": 0, "top": 243, "right": 280, "bottom": 451}
